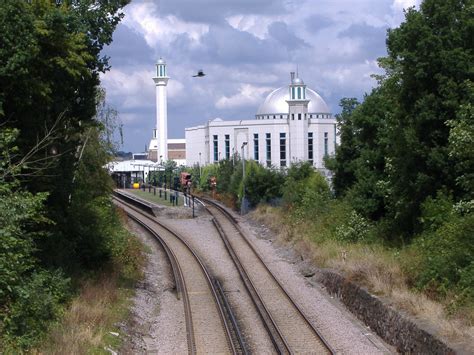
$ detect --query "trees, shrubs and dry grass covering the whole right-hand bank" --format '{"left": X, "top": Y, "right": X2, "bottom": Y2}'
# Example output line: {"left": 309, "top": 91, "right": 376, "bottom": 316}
{"left": 194, "top": 0, "right": 474, "bottom": 342}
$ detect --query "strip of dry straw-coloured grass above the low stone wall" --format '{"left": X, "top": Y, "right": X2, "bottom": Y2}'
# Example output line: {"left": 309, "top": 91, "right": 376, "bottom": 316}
{"left": 251, "top": 206, "right": 474, "bottom": 352}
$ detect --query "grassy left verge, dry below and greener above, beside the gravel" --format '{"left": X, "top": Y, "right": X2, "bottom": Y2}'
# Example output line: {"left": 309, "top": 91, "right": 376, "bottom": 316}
{"left": 32, "top": 212, "right": 145, "bottom": 355}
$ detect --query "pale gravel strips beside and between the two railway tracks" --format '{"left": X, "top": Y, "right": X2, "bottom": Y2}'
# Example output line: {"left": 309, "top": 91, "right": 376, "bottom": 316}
{"left": 124, "top": 200, "right": 394, "bottom": 354}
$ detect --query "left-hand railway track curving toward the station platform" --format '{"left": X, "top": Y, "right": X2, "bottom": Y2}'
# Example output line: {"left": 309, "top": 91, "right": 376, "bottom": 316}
{"left": 114, "top": 194, "right": 247, "bottom": 354}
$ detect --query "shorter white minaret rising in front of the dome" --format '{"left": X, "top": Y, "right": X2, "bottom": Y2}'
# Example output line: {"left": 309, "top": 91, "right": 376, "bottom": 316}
{"left": 286, "top": 72, "right": 309, "bottom": 165}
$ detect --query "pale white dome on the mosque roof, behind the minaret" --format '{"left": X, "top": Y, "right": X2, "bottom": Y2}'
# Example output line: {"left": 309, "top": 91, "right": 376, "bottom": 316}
{"left": 257, "top": 86, "right": 331, "bottom": 116}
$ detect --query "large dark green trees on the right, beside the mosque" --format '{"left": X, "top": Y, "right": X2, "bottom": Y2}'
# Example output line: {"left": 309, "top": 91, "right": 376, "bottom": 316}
{"left": 327, "top": 0, "right": 474, "bottom": 241}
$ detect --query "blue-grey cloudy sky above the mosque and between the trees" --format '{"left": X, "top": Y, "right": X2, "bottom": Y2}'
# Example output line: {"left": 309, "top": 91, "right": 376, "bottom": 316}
{"left": 101, "top": 0, "right": 421, "bottom": 152}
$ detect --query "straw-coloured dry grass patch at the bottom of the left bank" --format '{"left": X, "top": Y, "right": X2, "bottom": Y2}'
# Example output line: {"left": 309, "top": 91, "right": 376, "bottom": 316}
{"left": 33, "top": 273, "right": 130, "bottom": 354}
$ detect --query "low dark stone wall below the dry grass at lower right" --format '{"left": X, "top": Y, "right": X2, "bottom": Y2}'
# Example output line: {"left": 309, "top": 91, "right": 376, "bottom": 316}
{"left": 317, "top": 270, "right": 456, "bottom": 354}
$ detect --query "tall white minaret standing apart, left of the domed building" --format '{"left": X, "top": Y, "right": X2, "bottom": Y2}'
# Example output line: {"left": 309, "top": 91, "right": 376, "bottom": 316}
{"left": 153, "top": 58, "right": 169, "bottom": 163}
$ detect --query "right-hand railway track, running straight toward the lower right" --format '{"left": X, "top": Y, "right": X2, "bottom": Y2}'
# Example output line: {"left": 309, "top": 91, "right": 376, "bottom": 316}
{"left": 202, "top": 199, "right": 335, "bottom": 354}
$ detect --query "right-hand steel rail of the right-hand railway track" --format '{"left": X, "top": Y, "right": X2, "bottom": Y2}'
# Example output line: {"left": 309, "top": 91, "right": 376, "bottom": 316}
{"left": 201, "top": 198, "right": 335, "bottom": 354}
